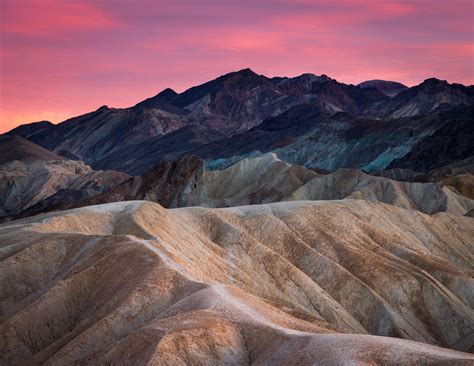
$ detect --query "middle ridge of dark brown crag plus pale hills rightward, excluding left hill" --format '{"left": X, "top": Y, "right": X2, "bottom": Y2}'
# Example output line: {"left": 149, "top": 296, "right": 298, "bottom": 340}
{"left": 16, "top": 153, "right": 474, "bottom": 218}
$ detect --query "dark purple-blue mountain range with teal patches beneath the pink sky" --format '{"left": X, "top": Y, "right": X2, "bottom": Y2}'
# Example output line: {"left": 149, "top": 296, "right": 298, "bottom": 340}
{"left": 11, "top": 69, "right": 474, "bottom": 175}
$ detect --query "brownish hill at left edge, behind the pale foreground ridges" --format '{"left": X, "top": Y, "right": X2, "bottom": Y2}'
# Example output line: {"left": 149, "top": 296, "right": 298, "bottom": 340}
{"left": 0, "top": 136, "right": 129, "bottom": 221}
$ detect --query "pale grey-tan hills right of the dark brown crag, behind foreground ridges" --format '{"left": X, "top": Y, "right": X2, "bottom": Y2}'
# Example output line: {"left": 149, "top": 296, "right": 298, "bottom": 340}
{"left": 197, "top": 153, "right": 474, "bottom": 215}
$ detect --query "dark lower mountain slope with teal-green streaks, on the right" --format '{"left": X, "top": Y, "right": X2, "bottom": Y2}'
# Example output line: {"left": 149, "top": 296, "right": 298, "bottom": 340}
{"left": 200, "top": 105, "right": 474, "bottom": 172}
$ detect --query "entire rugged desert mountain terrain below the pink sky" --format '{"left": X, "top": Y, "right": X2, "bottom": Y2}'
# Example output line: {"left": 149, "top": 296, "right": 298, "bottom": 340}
{"left": 0, "top": 69, "right": 474, "bottom": 365}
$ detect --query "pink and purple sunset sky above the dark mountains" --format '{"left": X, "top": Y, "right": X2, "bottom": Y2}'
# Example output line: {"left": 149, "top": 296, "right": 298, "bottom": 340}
{"left": 0, "top": 0, "right": 474, "bottom": 133}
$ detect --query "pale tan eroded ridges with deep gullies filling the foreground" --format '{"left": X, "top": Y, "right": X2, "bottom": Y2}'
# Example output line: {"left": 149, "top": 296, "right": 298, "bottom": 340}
{"left": 0, "top": 200, "right": 474, "bottom": 365}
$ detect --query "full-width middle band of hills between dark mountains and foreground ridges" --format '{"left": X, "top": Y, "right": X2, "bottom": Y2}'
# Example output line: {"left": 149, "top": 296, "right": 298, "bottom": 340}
{"left": 4, "top": 153, "right": 474, "bottom": 221}
